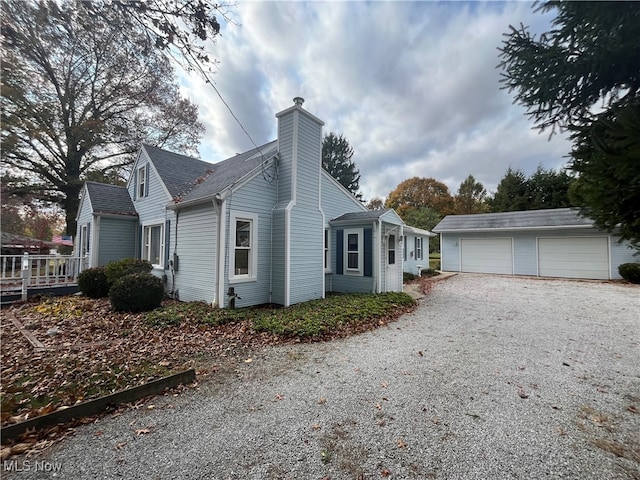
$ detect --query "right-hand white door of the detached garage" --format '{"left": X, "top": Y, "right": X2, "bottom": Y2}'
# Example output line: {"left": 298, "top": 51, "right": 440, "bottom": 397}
{"left": 538, "top": 237, "right": 609, "bottom": 279}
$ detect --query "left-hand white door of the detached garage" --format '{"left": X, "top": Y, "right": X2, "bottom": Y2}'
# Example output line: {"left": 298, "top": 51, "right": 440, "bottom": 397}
{"left": 460, "top": 238, "right": 513, "bottom": 274}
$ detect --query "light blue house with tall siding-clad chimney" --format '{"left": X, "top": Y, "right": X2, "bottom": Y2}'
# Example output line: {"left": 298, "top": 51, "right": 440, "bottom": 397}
{"left": 75, "top": 97, "right": 432, "bottom": 307}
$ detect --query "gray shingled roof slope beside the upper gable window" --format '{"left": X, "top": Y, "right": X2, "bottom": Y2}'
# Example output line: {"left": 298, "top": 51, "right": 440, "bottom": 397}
{"left": 142, "top": 145, "right": 214, "bottom": 198}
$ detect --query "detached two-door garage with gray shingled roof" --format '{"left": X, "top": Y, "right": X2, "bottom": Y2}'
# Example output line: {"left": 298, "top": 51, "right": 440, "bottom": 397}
{"left": 433, "top": 208, "right": 637, "bottom": 280}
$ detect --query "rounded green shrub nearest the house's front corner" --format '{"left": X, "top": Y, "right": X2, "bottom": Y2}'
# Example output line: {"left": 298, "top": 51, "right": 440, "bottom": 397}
{"left": 109, "top": 273, "right": 164, "bottom": 312}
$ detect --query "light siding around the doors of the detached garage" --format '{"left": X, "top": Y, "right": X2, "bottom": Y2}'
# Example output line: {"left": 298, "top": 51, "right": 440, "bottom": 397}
{"left": 440, "top": 228, "right": 636, "bottom": 279}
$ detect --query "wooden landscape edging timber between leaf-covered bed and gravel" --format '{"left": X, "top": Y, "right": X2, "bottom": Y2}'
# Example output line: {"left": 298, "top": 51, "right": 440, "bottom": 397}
{"left": 0, "top": 368, "right": 196, "bottom": 443}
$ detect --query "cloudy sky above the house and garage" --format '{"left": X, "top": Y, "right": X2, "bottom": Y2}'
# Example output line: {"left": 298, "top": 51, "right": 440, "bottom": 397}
{"left": 178, "top": 0, "right": 570, "bottom": 200}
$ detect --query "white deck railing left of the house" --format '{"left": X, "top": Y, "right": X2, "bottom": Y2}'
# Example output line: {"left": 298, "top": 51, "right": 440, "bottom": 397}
{"left": 0, "top": 253, "right": 84, "bottom": 300}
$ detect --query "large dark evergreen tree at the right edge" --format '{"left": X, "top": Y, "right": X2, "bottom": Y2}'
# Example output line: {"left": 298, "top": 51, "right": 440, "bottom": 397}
{"left": 499, "top": 0, "right": 640, "bottom": 245}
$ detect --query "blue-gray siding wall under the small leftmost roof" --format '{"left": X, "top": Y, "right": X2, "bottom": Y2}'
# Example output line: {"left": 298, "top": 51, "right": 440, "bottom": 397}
{"left": 94, "top": 216, "right": 138, "bottom": 266}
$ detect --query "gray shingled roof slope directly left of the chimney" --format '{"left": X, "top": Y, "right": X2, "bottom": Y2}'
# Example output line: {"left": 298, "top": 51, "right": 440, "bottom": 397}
{"left": 181, "top": 140, "right": 278, "bottom": 202}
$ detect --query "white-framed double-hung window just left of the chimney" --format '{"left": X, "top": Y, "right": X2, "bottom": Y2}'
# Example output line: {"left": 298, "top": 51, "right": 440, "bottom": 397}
{"left": 229, "top": 212, "right": 258, "bottom": 281}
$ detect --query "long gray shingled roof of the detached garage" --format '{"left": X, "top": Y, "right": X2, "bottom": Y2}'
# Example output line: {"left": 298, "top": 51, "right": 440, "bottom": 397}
{"left": 433, "top": 208, "right": 593, "bottom": 233}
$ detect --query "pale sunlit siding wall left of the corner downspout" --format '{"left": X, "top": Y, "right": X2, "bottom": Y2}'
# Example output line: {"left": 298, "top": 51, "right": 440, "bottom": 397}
{"left": 172, "top": 203, "right": 217, "bottom": 303}
